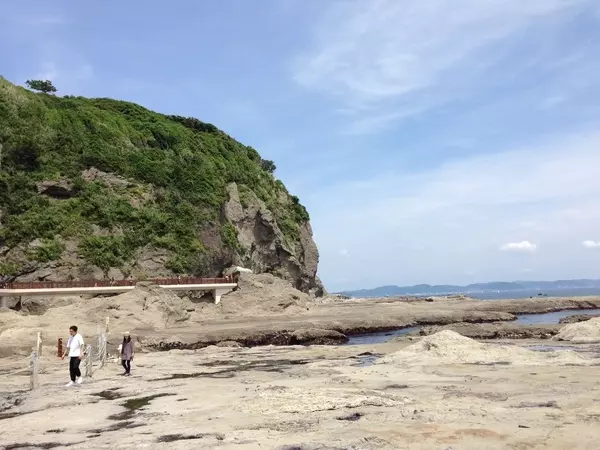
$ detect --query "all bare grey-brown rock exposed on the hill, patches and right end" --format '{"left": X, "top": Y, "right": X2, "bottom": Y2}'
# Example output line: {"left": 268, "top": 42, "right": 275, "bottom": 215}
{"left": 0, "top": 178, "right": 326, "bottom": 297}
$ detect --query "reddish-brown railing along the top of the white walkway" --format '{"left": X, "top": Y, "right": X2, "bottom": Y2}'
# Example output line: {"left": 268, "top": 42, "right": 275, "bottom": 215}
{"left": 0, "top": 277, "right": 233, "bottom": 289}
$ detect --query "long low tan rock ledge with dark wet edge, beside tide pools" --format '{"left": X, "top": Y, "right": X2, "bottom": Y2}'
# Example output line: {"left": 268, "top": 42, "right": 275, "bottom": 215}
{"left": 139, "top": 297, "right": 600, "bottom": 350}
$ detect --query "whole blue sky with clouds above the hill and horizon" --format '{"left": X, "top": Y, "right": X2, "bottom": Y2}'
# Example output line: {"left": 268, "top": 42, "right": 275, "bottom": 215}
{"left": 0, "top": 0, "right": 600, "bottom": 291}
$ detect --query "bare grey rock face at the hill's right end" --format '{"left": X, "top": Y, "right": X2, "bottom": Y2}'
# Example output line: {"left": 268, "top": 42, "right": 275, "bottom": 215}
{"left": 222, "top": 183, "right": 324, "bottom": 297}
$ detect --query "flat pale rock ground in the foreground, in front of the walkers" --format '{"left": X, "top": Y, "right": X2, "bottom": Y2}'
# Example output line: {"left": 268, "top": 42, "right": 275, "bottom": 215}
{"left": 0, "top": 332, "right": 600, "bottom": 450}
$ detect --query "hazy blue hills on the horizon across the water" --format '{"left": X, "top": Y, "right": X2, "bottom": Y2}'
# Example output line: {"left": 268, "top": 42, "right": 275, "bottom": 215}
{"left": 340, "top": 279, "right": 600, "bottom": 297}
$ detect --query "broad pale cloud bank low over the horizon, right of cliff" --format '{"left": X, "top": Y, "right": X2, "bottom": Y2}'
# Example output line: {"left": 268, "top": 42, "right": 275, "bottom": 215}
{"left": 311, "top": 126, "right": 600, "bottom": 286}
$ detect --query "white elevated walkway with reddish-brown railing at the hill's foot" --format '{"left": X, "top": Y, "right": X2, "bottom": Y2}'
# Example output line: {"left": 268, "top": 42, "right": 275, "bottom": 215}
{"left": 0, "top": 277, "right": 237, "bottom": 303}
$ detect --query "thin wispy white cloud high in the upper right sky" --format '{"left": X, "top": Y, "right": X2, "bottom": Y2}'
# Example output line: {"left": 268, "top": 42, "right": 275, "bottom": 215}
{"left": 293, "top": 0, "right": 594, "bottom": 133}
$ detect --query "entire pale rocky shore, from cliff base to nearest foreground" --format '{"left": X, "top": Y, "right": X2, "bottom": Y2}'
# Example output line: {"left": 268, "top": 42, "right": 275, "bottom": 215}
{"left": 0, "top": 275, "right": 600, "bottom": 450}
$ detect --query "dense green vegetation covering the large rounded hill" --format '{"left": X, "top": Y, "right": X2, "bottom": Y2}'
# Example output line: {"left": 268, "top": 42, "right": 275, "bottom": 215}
{"left": 0, "top": 77, "right": 308, "bottom": 275}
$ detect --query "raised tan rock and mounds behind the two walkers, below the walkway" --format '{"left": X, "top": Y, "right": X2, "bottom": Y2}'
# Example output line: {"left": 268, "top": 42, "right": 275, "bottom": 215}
{"left": 0, "top": 274, "right": 600, "bottom": 358}
